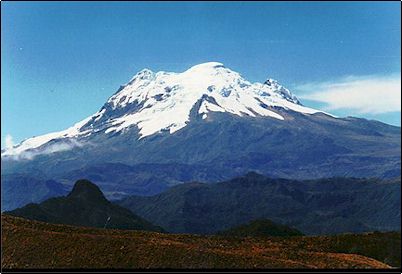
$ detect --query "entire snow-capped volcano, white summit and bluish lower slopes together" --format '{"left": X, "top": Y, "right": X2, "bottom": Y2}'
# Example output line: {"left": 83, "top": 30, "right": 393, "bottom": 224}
{"left": 1, "top": 62, "right": 401, "bottom": 208}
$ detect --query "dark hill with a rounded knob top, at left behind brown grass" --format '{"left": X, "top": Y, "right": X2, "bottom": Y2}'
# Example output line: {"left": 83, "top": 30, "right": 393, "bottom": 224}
{"left": 6, "top": 180, "right": 163, "bottom": 232}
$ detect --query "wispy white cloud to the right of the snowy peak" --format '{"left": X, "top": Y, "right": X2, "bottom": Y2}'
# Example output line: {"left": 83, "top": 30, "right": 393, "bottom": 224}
{"left": 296, "top": 75, "right": 401, "bottom": 114}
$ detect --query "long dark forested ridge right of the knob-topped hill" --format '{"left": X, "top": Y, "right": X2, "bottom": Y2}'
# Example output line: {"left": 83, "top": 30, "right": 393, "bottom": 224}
{"left": 118, "top": 173, "right": 401, "bottom": 235}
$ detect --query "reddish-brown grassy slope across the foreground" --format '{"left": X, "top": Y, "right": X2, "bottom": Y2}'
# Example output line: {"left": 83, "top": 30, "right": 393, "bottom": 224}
{"left": 1, "top": 215, "right": 389, "bottom": 268}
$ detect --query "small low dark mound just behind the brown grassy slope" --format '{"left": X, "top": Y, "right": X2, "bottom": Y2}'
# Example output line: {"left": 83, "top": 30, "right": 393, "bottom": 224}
{"left": 217, "top": 219, "right": 303, "bottom": 237}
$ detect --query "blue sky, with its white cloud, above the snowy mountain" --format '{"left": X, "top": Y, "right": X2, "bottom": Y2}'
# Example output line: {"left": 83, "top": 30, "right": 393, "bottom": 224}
{"left": 1, "top": 2, "right": 401, "bottom": 147}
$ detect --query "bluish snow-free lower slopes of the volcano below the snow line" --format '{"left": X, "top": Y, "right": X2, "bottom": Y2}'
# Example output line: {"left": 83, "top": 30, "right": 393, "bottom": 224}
{"left": 1, "top": 111, "right": 401, "bottom": 206}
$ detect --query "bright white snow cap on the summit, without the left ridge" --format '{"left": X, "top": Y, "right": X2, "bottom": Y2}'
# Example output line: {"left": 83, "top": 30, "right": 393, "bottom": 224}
{"left": 105, "top": 62, "right": 317, "bottom": 138}
